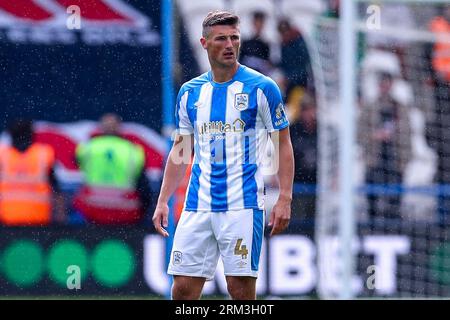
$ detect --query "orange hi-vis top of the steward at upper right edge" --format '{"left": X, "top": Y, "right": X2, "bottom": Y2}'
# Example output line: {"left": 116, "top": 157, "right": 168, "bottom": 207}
{"left": 430, "top": 17, "right": 450, "bottom": 82}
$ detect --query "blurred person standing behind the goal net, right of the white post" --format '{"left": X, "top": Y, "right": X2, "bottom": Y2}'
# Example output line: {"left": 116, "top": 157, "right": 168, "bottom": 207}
{"left": 358, "top": 71, "right": 412, "bottom": 219}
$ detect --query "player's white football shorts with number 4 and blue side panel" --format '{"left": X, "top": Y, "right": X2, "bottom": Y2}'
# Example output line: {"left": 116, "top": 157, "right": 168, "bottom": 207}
{"left": 168, "top": 209, "right": 264, "bottom": 280}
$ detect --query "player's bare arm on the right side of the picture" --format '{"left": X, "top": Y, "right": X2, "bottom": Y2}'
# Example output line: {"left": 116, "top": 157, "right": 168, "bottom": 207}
{"left": 269, "top": 127, "right": 294, "bottom": 236}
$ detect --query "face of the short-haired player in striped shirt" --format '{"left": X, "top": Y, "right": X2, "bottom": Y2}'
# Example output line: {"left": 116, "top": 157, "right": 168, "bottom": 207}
{"left": 201, "top": 25, "right": 241, "bottom": 67}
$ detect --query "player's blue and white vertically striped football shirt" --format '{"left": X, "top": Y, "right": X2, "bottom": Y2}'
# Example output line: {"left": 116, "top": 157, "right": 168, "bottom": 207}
{"left": 175, "top": 65, "right": 289, "bottom": 212}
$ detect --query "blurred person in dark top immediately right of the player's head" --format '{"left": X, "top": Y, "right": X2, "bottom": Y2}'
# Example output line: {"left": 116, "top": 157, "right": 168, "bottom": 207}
{"left": 240, "top": 11, "right": 272, "bottom": 75}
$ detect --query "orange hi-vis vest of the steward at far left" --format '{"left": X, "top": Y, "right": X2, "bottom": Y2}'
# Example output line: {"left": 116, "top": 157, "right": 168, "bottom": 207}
{"left": 0, "top": 143, "right": 55, "bottom": 226}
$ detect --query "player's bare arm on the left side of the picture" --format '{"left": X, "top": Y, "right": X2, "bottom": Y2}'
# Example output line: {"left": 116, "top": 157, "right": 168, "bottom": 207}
{"left": 152, "top": 134, "right": 194, "bottom": 237}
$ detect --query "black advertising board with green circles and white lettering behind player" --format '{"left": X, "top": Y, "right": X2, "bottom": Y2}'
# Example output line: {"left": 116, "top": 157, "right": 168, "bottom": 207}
{"left": 0, "top": 222, "right": 450, "bottom": 299}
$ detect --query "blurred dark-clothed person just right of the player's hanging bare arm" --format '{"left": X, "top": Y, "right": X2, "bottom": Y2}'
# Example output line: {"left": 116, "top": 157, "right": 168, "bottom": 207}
{"left": 287, "top": 92, "right": 318, "bottom": 219}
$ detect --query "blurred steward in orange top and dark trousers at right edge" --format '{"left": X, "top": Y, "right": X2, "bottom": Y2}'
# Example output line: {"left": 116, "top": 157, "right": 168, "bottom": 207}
{"left": 426, "top": 6, "right": 450, "bottom": 223}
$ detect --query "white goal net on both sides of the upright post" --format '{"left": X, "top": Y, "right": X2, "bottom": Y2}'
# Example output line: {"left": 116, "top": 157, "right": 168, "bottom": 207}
{"left": 311, "top": 0, "right": 450, "bottom": 298}
